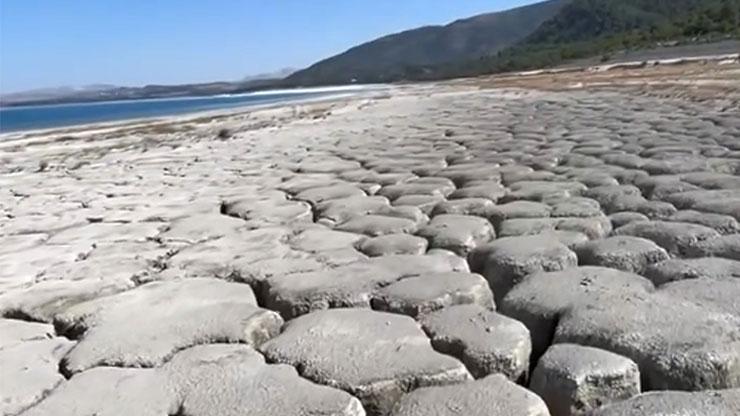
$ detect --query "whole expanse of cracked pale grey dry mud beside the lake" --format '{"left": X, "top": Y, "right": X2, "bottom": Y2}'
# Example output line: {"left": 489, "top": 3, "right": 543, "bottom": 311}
{"left": 0, "top": 61, "right": 740, "bottom": 416}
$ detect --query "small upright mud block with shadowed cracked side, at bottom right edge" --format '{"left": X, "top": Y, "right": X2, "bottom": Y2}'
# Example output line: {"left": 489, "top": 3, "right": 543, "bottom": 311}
{"left": 529, "top": 344, "right": 640, "bottom": 416}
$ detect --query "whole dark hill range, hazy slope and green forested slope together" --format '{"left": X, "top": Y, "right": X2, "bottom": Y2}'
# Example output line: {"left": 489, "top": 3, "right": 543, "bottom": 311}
{"left": 285, "top": 0, "right": 740, "bottom": 85}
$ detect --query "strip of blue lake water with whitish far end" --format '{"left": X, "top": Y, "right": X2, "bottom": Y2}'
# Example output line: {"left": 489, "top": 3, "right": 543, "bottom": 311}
{"left": 0, "top": 85, "right": 371, "bottom": 133}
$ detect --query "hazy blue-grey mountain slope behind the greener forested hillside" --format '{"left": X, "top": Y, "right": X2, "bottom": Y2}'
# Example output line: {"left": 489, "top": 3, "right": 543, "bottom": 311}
{"left": 286, "top": 0, "right": 567, "bottom": 85}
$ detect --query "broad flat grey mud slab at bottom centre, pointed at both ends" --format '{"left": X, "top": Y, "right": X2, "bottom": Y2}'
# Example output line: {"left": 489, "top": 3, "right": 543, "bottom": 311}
{"left": 260, "top": 309, "right": 471, "bottom": 415}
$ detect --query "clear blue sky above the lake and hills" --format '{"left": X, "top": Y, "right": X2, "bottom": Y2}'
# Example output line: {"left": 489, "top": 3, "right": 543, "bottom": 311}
{"left": 0, "top": 0, "right": 535, "bottom": 93}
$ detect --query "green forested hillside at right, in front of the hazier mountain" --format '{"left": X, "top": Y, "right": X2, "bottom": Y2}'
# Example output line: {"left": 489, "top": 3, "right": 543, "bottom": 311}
{"left": 422, "top": 0, "right": 740, "bottom": 79}
